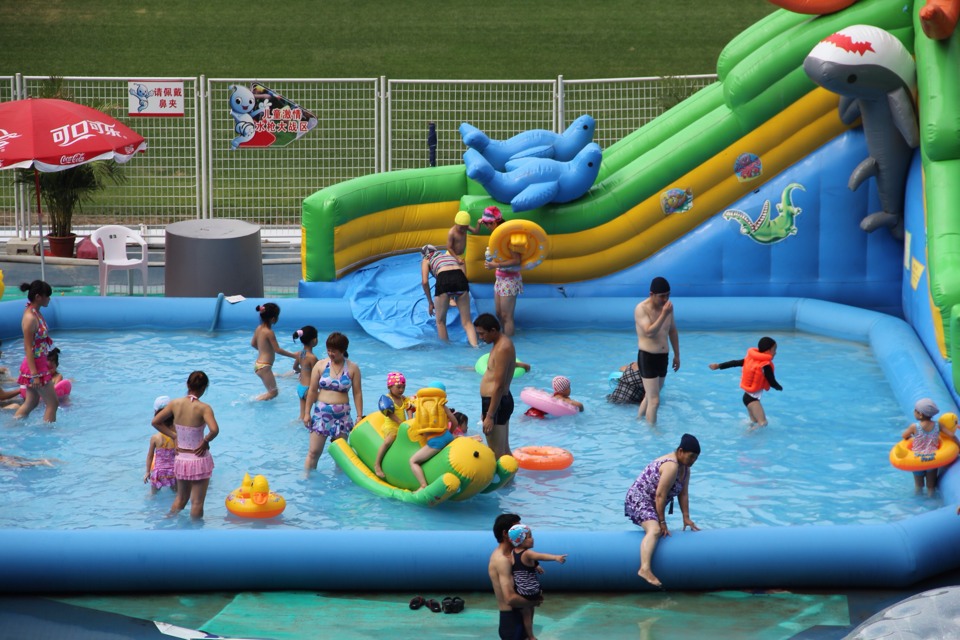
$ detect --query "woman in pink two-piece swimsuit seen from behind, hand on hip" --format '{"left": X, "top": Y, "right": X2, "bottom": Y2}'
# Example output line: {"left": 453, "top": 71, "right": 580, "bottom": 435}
{"left": 151, "top": 371, "right": 220, "bottom": 519}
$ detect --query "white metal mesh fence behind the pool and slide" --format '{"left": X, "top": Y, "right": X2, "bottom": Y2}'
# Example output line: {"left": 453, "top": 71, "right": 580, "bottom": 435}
{"left": 0, "top": 75, "right": 715, "bottom": 239}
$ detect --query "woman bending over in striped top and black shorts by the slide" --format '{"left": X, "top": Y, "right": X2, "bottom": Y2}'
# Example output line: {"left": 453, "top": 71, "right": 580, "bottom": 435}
{"left": 420, "top": 244, "right": 477, "bottom": 347}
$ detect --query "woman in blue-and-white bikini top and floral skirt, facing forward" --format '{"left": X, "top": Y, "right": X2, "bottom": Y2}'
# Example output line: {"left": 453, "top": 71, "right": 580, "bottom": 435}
{"left": 303, "top": 331, "right": 363, "bottom": 471}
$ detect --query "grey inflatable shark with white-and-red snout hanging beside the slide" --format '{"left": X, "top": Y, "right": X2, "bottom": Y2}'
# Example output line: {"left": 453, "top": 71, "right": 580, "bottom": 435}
{"left": 803, "top": 25, "right": 920, "bottom": 238}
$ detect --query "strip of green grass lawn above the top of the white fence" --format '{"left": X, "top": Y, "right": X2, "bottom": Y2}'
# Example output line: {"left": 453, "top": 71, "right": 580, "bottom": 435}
{"left": 0, "top": 0, "right": 775, "bottom": 79}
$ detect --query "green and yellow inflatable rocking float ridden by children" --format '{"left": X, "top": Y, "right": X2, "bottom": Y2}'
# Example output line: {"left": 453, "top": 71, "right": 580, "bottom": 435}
{"left": 330, "top": 387, "right": 518, "bottom": 506}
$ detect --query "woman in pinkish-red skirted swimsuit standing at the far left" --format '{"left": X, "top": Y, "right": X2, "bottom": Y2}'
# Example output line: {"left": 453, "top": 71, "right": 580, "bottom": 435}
{"left": 15, "top": 280, "right": 60, "bottom": 422}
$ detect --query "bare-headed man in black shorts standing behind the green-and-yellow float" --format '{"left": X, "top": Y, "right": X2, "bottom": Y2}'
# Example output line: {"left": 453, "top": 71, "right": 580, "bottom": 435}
{"left": 473, "top": 313, "right": 517, "bottom": 459}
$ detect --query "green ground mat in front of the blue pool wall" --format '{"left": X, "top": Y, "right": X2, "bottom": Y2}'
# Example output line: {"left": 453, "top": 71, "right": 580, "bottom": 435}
{"left": 58, "top": 591, "right": 850, "bottom": 640}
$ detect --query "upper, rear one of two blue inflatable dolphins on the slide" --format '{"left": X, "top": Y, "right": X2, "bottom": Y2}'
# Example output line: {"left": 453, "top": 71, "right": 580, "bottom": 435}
{"left": 460, "top": 115, "right": 597, "bottom": 171}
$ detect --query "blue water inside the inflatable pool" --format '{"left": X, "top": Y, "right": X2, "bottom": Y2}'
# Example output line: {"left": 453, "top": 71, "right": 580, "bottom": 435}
{"left": 0, "top": 324, "right": 941, "bottom": 530}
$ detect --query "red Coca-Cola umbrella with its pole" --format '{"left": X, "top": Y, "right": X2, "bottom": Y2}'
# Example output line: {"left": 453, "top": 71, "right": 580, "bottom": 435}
{"left": 0, "top": 98, "right": 147, "bottom": 278}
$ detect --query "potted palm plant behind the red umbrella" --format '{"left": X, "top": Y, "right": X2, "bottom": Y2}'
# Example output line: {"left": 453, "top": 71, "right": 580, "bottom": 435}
{"left": 15, "top": 77, "right": 126, "bottom": 257}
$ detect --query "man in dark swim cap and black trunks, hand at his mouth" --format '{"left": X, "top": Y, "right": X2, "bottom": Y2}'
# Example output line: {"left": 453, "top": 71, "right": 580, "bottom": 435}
{"left": 633, "top": 276, "right": 680, "bottom": 427}
